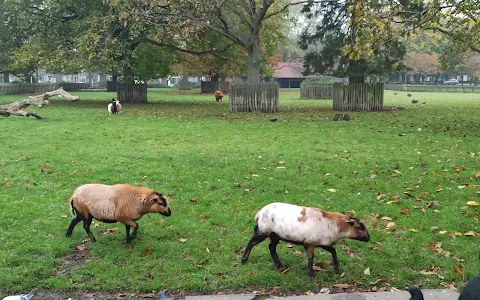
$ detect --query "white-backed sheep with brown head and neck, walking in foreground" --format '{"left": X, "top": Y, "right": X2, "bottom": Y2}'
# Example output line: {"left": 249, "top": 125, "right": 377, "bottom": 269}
{"left": 241, "top": 202, "right": 370, "bottom": 277}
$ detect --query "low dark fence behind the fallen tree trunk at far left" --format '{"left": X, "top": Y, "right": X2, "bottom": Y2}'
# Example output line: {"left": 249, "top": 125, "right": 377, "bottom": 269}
{"left": 0, "top": 82, "right": 89, "bottom": 95}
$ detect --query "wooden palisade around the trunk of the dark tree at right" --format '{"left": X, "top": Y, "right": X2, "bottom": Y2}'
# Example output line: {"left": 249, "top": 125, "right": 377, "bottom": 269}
{"left": 333, "top": 83, "right": 383, "bottom": 111}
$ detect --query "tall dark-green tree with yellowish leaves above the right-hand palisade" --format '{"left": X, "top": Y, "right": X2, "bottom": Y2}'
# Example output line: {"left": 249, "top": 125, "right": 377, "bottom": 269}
{"left": 300, "top": 0, "right": 406, "bottom": 82}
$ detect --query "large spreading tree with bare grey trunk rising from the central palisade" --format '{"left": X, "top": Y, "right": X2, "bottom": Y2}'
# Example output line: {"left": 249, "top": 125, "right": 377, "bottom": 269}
{"left": 109, "top": 0, "right": 296, "bottom": 82}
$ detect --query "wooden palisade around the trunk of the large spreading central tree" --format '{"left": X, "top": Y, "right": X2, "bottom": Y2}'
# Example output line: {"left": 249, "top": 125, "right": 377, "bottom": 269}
{"left": 229, "top": 82, "right": 280, "bottom": 113}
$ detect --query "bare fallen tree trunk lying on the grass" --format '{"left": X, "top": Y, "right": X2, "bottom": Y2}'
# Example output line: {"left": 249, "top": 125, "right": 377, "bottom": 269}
{"left": 0, "top": 87, "right": 80, "bottom": 119}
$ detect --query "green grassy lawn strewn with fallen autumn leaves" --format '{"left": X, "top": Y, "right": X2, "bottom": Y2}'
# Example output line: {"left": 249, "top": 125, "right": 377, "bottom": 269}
{"left": 0, "top": 89, "right": 480, "bottom": 295}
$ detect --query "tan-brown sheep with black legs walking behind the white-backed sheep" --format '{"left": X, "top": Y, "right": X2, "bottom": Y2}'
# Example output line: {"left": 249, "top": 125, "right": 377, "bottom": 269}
{"left": 65, "top": 184, "right": 171, "bottom": 243}
